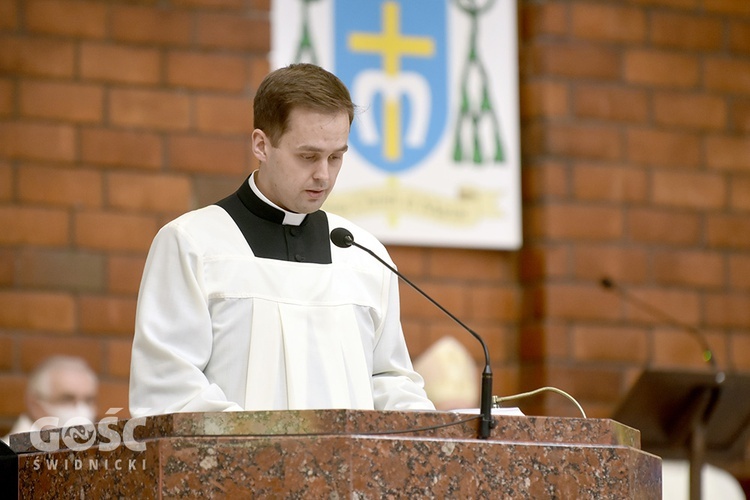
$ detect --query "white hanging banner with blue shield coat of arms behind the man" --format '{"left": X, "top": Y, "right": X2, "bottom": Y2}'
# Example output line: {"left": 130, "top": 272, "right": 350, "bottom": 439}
{"left": 271, "top": 0, "right": 521, "bottom": 249}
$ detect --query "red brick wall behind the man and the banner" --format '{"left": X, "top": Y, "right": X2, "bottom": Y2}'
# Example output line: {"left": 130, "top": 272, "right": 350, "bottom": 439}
{"left": 0, "top": 0, "right": 750, "bottom": 478}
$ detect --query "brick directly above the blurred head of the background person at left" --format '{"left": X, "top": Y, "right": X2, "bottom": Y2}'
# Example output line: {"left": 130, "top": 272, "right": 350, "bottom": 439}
{"left": 20, "top": 336, "right": 103, "bottom": 376}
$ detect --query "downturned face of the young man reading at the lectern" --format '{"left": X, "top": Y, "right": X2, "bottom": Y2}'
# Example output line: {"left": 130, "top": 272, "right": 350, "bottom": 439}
{"left": 252, "top": 108, "right": 349, "bottom": 214}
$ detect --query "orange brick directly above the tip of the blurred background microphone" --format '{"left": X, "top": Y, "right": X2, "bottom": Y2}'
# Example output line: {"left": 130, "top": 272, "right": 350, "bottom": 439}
{"left": 573, "top": 244, "right": 649, "bottom": 285}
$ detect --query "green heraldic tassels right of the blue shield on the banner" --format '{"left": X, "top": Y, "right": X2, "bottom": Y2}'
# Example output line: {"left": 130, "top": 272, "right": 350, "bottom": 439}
{"left": 453, "top": 0, "right": 505, "bottom": 164}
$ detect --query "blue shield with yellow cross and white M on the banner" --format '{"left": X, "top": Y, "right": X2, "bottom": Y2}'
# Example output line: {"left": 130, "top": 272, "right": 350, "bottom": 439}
{"left": 334, "top": 0, "right": 448, "bottom": 173}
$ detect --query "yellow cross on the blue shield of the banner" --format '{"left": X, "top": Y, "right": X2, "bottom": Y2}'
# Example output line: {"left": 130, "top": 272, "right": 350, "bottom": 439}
{"left": 349, "top": 2, "right": 435, "bottom": 160}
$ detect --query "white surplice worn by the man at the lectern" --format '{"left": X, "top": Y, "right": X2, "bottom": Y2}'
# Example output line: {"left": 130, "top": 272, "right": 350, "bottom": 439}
{"left": 130, "top": 205, "right": 434, "bottom": 416}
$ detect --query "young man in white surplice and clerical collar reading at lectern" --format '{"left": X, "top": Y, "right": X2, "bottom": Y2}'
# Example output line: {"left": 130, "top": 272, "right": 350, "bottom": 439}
{"left": 130, "top": 64, "right": 434, "bottom": 416}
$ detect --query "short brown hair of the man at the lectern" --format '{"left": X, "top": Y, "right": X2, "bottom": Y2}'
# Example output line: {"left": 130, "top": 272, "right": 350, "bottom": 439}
{"left": 253, "top": 63, "right": 354, "bottom": 146}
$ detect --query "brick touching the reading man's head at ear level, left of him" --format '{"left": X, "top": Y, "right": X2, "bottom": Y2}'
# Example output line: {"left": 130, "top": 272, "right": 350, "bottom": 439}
{"left": 169, "top": 136, "right": 248, "bottom": 177}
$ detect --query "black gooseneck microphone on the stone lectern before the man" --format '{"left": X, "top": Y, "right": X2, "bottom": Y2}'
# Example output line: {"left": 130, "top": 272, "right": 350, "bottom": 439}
{"left": 331, "top": 227, "right": 495, "bottom": 439}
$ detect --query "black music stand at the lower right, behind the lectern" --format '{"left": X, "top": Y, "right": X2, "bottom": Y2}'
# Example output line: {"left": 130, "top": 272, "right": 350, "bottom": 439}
{"left": 613, "top": 370, "right": 750, "bottom": 500}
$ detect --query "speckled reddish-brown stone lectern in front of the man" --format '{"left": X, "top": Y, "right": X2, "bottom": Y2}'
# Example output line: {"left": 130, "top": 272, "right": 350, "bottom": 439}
{"left": 11, "top": 410, "right": 661, "bottom": 499}
